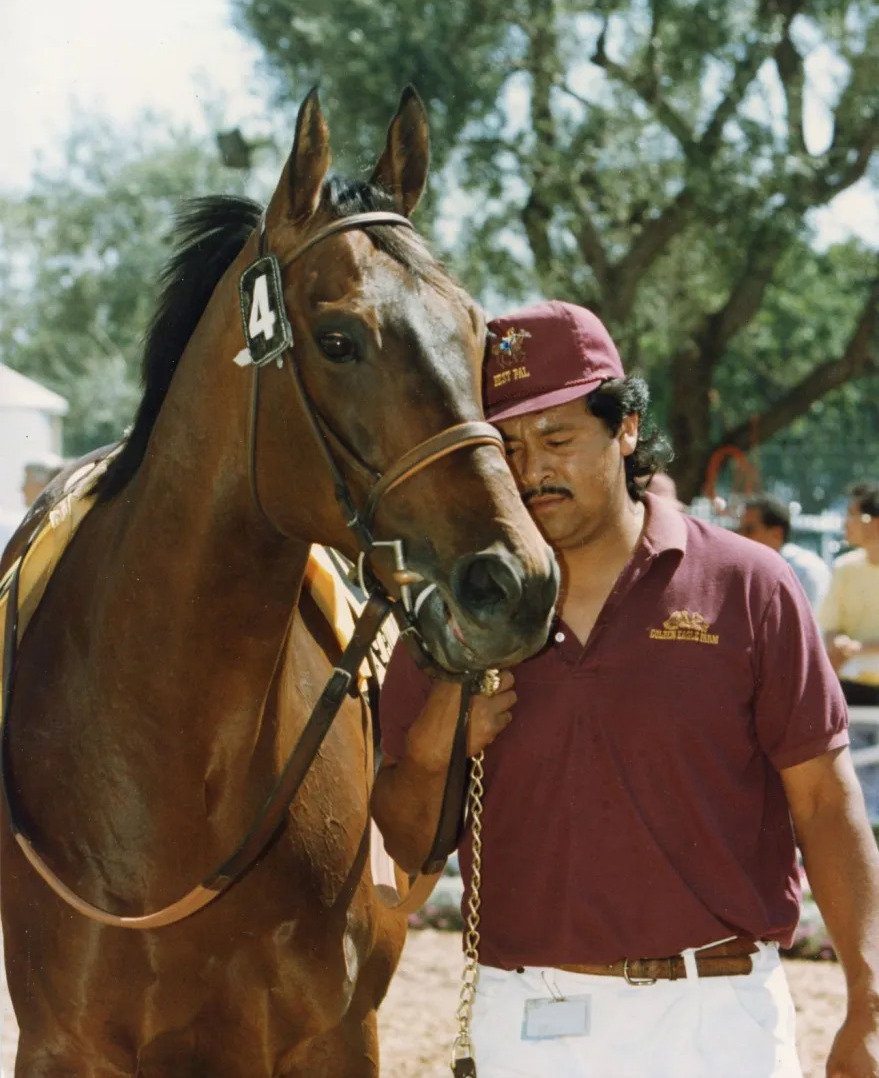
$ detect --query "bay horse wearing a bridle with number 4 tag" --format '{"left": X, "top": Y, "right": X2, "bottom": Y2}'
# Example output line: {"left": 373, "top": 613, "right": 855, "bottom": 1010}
{"left": 0, "top": 88, "right": 557, "bottom": 1078}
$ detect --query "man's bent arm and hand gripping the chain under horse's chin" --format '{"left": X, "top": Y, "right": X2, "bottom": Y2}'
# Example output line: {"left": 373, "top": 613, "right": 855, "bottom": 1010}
{"left": 372, "top": 671, "right": 516, "bottom": 873}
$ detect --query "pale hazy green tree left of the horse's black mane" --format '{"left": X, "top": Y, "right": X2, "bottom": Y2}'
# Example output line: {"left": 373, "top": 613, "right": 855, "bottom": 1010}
{"left": 0, "top": 118, "right": 249, "bottom": 455}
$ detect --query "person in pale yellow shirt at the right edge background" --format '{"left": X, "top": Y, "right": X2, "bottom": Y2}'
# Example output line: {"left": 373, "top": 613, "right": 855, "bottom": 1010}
{"left": 819, "top": 481, "right": 879, "bottom": 704}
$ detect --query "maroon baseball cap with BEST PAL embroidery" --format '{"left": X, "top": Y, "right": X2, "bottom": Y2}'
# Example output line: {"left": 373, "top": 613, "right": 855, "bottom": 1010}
{"left": 483, "top": 300, "right": 626, "bottom": 423}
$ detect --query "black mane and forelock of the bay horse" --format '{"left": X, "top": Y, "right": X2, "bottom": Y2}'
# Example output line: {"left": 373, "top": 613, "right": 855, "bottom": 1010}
{"left": 94, "top": 177, "right": 458, "bottom": 500}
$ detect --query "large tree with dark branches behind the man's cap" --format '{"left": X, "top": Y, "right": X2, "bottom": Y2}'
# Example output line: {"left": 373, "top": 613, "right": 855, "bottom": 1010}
{"left": 235, "top": 0, "right": 879, "bottom": 498}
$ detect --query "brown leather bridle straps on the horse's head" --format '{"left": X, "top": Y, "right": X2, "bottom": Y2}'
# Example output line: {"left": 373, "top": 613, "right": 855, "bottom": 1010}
{"left": 243, "top": 210, "right": 504, "bottom": 619}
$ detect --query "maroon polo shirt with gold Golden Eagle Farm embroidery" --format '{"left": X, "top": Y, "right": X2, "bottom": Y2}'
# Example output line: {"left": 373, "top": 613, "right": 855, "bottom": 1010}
{"left": 382, "top": 495, "right": 848, "bottom": 969}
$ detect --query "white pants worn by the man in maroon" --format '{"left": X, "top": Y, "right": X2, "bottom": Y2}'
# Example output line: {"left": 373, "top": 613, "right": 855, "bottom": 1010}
{"left": 471, "top": 944, "right": 802, "bottom": 1078}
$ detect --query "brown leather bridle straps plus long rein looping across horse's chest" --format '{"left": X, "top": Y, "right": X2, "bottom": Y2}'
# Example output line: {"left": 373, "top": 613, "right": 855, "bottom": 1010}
{"left": 0, "top": 211, "right": 504, "bottom": 929}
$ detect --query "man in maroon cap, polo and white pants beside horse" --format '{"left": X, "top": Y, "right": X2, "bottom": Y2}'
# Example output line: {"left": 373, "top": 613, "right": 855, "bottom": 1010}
{"left": 373, "top": 302, "right": 879, "bottom": 1078}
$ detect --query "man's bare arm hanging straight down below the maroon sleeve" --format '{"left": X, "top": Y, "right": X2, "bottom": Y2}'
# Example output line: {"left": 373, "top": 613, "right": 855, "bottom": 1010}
{"left": 781, "top": 748, "right": 879, "bottom": 1078}
